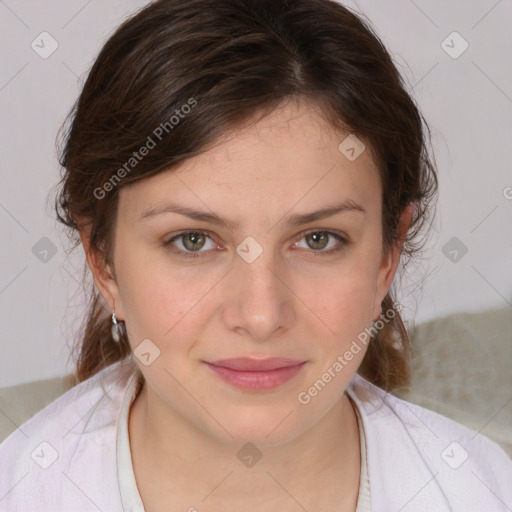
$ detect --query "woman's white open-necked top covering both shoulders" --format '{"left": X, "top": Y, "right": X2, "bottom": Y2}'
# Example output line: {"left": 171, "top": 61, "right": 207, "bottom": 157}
{"left": 0, "top": 359, "right": 512, "bottom": 512}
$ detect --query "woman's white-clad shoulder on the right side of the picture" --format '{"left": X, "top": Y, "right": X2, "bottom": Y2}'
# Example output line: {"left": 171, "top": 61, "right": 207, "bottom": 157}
{"left": 347, "top": 374, "right": 512, "bottom": 512}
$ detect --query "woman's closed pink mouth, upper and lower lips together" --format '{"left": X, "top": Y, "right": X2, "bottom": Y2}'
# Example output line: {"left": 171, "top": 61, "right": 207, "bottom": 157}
{"left": 205, "top": 357, "right": 307, "bottom": 391}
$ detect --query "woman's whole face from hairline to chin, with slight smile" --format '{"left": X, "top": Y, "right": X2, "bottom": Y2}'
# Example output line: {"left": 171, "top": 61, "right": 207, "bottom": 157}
{"left": 87, "top": 98, "right": 398, "bottom": 446}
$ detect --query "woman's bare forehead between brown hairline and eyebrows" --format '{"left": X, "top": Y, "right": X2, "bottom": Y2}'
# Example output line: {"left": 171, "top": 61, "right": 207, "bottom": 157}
{"left": 119, "top": 102, "right": 380, "bottom": 225}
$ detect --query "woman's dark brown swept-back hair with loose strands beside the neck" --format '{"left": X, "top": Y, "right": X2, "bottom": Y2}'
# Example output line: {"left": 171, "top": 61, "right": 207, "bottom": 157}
{"left": 55, "top": 0, "right": 437, "bottom": 390}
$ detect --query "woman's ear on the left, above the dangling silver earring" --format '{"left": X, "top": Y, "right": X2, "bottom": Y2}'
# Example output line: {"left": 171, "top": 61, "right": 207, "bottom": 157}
{"left": 80, "top": 227, "right": 124, "bottom": 320}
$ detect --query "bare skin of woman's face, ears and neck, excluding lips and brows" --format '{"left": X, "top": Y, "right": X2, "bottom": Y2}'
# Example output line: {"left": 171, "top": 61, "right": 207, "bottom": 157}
{"left": 82, "top": 101, "right": 407, "bottom": 512}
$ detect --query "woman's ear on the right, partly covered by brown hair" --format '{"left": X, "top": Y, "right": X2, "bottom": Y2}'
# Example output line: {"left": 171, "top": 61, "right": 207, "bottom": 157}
{"left": 373, "top": 203, "right": 415, "bottom": 321}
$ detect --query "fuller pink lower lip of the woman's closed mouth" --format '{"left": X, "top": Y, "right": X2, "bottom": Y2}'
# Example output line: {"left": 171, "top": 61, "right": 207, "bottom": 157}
{"left": 206, "top": 362, "right": 306, "bottom": 391}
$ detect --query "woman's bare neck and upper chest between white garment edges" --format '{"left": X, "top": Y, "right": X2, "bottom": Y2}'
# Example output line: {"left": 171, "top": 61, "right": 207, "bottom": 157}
{"left": 129, "top": 383, "right": 360, "bottom": 511}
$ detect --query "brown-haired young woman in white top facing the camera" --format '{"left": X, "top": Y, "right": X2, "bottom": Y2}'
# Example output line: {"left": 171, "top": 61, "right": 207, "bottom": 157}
{"left": 0, "top": 0, "right": 512, "bottom": 512}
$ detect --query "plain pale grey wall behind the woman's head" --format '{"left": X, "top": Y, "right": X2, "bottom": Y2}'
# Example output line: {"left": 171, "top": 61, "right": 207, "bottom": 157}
{"left": 0, "top": 0, "right": 512, "bottom": 387}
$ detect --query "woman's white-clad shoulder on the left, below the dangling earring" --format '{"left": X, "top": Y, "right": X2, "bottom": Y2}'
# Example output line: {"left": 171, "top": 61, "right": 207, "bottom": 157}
{"left": 0, "top": 360, "right": 135, "bottom": 511}
